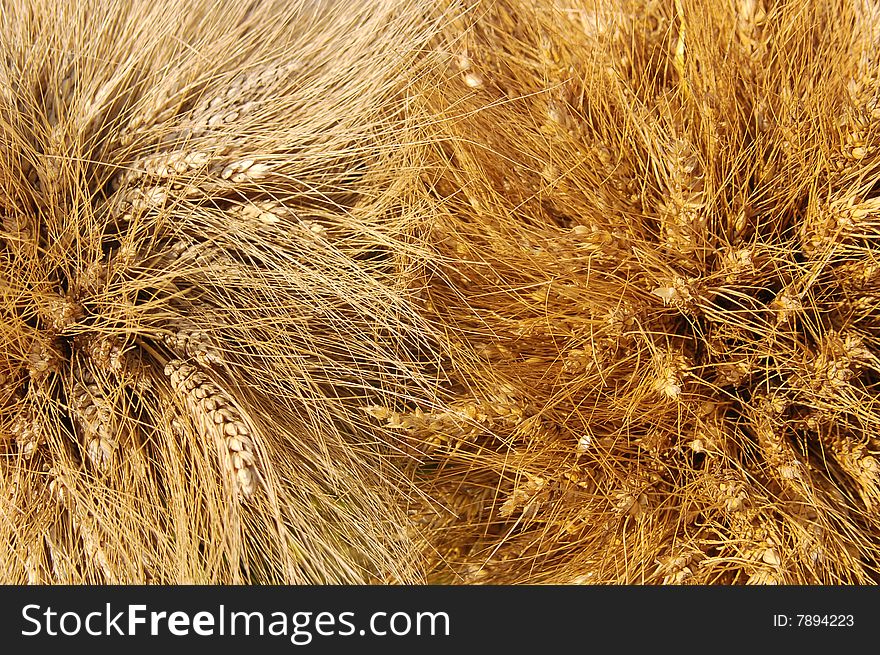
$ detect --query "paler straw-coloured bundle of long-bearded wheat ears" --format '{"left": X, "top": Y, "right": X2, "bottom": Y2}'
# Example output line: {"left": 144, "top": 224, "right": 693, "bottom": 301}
{"left": 0, "top": 0, "right": 454, "bottom": 583}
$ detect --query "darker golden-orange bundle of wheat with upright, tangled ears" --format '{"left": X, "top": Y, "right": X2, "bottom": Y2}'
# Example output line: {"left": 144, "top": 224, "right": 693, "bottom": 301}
{"left": 394, "top": 0, "right": 880, "bottom": 584}
